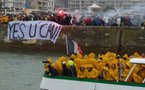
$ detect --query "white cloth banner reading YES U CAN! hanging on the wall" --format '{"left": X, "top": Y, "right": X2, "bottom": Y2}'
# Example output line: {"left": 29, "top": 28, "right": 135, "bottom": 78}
{"left": 8, "top": 21, "right": 62, "bottom": 43}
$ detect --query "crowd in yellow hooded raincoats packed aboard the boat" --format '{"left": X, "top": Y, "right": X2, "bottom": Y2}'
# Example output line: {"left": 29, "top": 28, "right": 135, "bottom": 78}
{"left": 43, "top": 52, "right": 145, "bottom": 83}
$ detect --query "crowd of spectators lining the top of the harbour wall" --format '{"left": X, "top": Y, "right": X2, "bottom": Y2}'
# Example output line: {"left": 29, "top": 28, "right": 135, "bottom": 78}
{"left": 1, "top": 12, "right": 145, "bottom": 26}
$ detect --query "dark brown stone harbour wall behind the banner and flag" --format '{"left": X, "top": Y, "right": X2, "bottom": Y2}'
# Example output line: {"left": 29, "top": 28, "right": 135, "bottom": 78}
{"left": 0, "top": 25, "right": 145, "bottom": 54}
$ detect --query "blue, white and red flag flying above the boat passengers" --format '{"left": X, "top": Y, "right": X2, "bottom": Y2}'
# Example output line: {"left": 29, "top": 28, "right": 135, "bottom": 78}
{"left": 66, "top": 36, "right": 83, "bottom": 55}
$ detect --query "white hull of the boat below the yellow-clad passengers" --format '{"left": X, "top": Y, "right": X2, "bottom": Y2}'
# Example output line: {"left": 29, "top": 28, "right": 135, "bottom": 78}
{"left": 40, "top": 77, "right": 145, "bottom": 90}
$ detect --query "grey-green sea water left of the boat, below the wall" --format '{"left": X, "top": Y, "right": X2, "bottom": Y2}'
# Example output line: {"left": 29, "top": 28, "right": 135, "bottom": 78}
{"left": 0, "top": 52, "right": 61, "bottom": 90}
